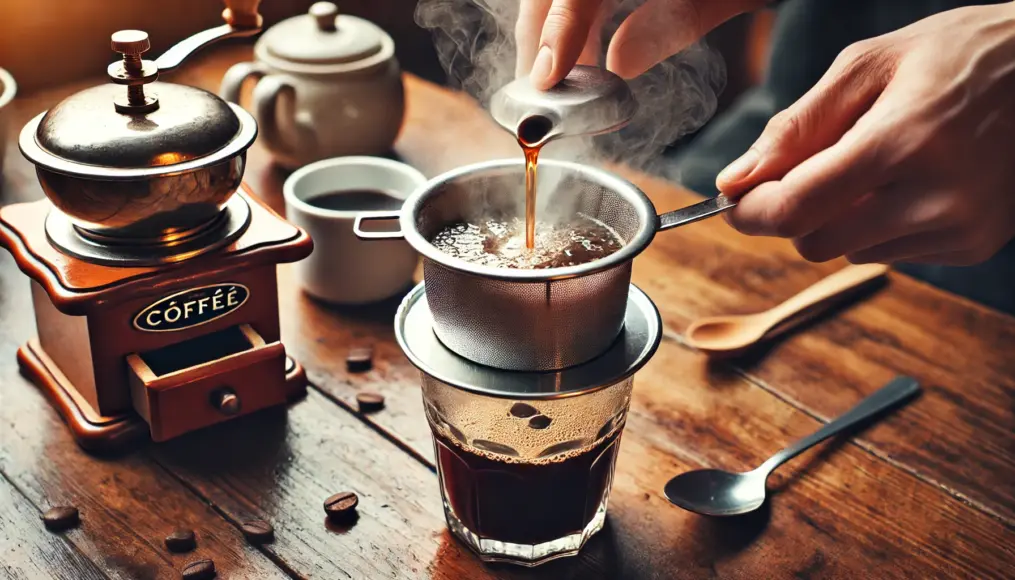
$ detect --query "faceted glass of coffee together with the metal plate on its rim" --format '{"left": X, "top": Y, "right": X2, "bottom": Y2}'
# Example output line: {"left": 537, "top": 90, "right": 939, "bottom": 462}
{"left": 396, "top": 284, "right": 661, "bottom": 566}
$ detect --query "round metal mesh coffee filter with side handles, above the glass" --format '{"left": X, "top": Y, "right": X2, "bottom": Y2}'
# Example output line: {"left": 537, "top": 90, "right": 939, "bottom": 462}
{"left": 355, "top": 159, "right": 734, "bottom": 371}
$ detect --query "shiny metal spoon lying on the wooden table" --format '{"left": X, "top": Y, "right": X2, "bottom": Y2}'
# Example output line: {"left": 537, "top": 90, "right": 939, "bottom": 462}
{"left": 665, "top": 376, "right": 920, "bottom": 516}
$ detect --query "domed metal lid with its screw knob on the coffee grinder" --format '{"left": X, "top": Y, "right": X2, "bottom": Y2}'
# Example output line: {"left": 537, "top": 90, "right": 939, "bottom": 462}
{"left": 19, "top": 30, "right": 257, "bottom": 180}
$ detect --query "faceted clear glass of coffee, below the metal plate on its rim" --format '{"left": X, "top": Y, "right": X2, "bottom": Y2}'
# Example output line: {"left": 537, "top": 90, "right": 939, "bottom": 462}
{"left": 423, "top": 377, "right": 632, "bottom": 564}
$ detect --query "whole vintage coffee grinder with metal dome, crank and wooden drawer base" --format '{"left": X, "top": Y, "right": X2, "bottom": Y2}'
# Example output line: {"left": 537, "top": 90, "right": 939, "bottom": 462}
{"left": 0, "top": 0, "right": 313, "bottom": 450}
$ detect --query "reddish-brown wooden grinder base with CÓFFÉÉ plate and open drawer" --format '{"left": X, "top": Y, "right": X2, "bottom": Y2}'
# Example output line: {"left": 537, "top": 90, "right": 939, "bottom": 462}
{"left": 0, "top": 187, "right": 313, "bottom": 451}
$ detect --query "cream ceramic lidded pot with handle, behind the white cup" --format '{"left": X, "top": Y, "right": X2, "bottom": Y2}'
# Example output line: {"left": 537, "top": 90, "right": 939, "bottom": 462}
{"left": 219, "top": 2, "right": 405, "bottom": 169}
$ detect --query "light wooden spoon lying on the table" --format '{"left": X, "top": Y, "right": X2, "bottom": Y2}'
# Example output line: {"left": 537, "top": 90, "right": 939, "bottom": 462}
{"left": 686, "top": 264, "right": 888, "bottom": 356}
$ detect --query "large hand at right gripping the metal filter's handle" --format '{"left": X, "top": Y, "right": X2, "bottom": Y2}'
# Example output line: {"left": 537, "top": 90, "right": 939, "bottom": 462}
{"left": 717, "top": 3, "right": 1015, "bottom": 265}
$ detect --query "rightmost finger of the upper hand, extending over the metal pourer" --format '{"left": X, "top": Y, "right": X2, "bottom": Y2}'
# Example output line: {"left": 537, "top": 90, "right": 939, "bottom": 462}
{"left": 606, "top": 0, "right": 760, "bottom": 78}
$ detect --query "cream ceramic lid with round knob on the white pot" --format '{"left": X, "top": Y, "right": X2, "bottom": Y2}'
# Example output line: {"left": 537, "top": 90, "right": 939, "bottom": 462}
{"left": 258, "top": 2, "right": 392, "bottom": 65}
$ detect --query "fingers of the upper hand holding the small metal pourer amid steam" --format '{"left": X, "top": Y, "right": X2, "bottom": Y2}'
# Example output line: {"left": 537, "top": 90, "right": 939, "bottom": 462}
{"left": 515, "top": 0, "right": 765, "bottom": 89}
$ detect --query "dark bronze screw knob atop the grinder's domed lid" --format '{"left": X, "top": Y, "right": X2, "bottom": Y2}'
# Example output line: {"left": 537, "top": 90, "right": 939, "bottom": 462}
{"left": 106, "top": 30, "right": 158, "bottom": 115}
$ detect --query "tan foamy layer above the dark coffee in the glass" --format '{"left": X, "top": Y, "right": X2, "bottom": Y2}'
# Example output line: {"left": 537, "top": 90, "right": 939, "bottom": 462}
{"left": 423, "top": 375, "right": 632, "bottom": 465}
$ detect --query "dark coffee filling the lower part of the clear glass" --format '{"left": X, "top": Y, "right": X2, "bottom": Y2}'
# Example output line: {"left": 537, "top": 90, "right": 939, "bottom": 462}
{"left": 433, "top": 429, "right": 620, "bottom": 544}
